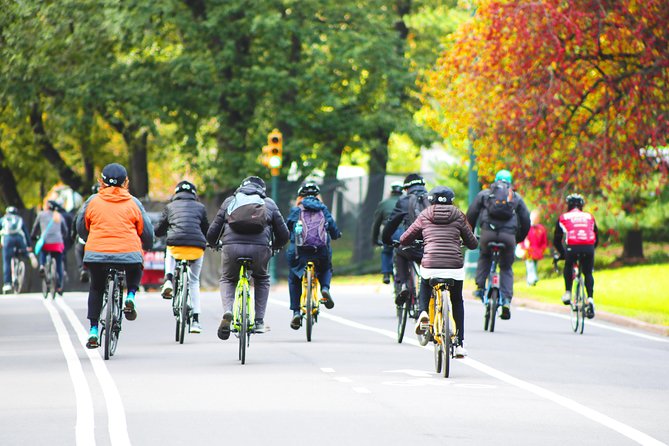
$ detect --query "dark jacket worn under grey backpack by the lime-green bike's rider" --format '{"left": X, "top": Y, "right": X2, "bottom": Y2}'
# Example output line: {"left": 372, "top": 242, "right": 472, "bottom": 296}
{"left": 207, "top": 183, "right": 289, "bottom": 249}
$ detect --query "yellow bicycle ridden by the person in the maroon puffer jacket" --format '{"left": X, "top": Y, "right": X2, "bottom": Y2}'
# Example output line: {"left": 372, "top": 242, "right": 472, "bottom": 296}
{"left": 414, "top": 277, "right": 457, "bottom": 378}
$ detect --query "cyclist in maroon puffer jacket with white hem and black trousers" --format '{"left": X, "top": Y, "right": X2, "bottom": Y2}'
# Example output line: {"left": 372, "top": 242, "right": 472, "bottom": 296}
{"left": 400, "top": 186, "right": 478, "bottom": 358}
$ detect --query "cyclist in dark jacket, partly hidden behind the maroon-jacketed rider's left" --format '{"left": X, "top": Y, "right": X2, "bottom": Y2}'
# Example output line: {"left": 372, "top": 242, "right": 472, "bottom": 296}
{"left": 381, "top": 173, "right": 429, "bottom": 305}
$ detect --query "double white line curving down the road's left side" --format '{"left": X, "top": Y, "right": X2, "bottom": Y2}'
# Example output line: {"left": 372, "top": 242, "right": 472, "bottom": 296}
{"left": 40, "top": 298, "right": 130, "bottom": 446}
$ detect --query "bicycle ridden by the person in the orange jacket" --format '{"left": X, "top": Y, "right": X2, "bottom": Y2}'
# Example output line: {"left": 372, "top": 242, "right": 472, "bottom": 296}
{"left": 99, "top": 267, "right": 126, "bottom": 360}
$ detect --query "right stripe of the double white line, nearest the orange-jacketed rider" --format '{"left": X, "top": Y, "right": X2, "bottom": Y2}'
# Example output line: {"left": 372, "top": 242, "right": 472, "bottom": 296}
{"left": 56, "top": 299, "right": 130, "bottom": 446}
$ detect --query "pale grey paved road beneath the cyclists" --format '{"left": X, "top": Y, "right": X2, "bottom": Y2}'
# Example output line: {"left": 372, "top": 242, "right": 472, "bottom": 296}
{"left": 0, "top": 286, "right": 669, "bottom": 446}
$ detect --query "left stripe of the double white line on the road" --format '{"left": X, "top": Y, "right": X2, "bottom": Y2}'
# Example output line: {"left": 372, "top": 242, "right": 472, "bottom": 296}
{"left": 38, "top": 297, "right": 95, "bottom": 446}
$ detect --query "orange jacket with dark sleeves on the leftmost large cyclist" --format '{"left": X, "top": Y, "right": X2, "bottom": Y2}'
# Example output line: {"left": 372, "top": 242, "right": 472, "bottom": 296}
{"left": 76, "top": 186, "right": 153, "bottom": 263}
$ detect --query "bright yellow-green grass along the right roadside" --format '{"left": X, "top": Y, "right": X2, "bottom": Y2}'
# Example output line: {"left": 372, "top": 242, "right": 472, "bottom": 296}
{"left": 514, "top": 260, "right": 669, "bottom": 326}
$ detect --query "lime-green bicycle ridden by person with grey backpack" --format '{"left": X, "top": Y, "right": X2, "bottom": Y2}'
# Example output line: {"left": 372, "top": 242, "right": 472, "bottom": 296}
{"left": 230, "top": 257, "right": 255, "bottom": 364}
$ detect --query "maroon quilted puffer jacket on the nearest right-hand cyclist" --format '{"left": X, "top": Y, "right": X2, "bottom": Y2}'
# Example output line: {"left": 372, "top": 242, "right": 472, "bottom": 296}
{"left": 400, "top": 204, "right": 478, "bottom": 269}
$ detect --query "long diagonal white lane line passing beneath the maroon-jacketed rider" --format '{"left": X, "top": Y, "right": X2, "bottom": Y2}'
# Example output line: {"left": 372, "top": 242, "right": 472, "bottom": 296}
{"left": 270, "top": 299, "right": 666, "bottom": 446}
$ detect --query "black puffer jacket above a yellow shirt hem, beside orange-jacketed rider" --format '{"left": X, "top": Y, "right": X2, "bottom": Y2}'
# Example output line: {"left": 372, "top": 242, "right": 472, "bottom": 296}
{"left": 155, "top": 192, "right": 209, "bottom": 249}
